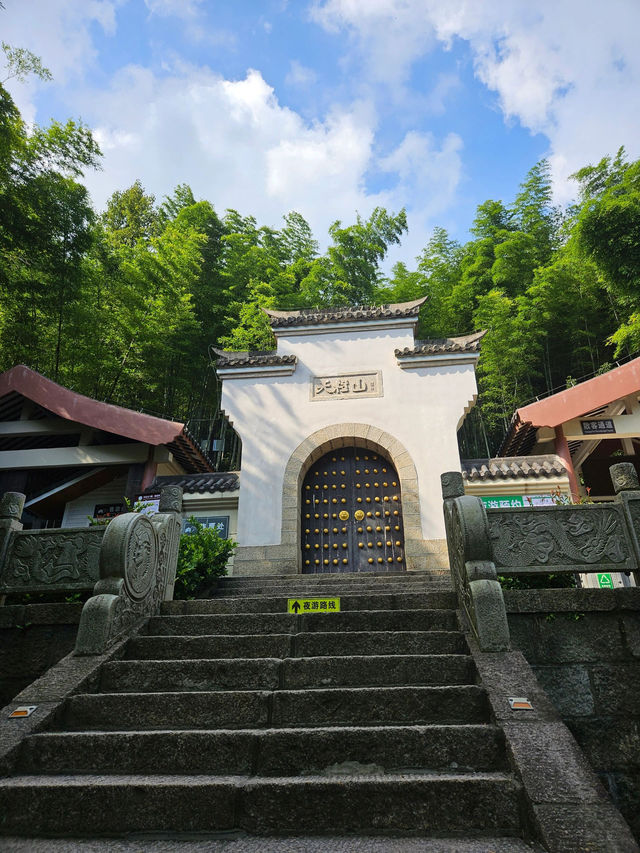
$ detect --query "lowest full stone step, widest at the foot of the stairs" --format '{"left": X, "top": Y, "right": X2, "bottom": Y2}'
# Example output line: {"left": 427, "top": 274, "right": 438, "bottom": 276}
{"left": 0, "top": 773, "right": 521, "bottom": 836}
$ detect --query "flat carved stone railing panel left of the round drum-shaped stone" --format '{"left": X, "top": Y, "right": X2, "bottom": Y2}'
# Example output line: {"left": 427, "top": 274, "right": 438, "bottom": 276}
{"left": 0, "top": 527, "right": 105, "bottom": 593}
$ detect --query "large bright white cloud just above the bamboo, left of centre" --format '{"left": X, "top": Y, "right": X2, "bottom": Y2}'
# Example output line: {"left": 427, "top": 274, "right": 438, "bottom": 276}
{"left": 79, "top": 66, "right": 384, "bottom": 237}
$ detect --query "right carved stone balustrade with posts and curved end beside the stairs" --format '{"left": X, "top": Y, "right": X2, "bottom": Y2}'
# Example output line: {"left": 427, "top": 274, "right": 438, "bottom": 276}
{"left": 441, "top": 462, "right": 640, "bottom": 651}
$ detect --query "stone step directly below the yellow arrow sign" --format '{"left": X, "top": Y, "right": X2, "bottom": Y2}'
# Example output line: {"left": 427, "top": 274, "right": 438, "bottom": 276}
{"left": 147, "top": 610, "right": 458, "bottom": 636}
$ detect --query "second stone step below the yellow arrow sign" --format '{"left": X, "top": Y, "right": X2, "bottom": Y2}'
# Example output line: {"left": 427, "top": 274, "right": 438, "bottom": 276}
{"left": 126, "top": 617, "right": 468, "bottom": 660}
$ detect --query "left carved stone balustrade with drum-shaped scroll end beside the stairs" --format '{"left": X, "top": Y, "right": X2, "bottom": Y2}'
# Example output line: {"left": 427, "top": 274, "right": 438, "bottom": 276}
{"left": 0, "top": 486, "right": 182, "bottom": 655}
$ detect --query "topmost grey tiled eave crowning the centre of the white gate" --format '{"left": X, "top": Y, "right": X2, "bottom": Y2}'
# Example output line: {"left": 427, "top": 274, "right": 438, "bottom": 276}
{"left": 263, "top": 297, "right": 426, "bottom": 337}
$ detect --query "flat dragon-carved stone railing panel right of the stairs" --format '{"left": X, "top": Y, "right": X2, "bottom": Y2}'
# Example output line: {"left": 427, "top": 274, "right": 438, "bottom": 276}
{"left": 487, "top": 504, "right": 637, "bottom": 574}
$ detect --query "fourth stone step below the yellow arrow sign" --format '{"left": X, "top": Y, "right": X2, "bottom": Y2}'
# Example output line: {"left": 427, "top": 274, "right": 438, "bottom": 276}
{"left": 62, "top": 685, "right": 489, "bottom": 731}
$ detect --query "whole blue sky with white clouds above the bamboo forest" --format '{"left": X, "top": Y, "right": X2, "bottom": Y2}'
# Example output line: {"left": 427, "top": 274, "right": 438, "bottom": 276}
{"left": 0, "top": 0, "right": 640, "bottom": 266}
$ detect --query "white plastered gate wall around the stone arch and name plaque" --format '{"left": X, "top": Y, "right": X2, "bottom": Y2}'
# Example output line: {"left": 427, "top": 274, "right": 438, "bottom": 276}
{"left": 220, "top": 325, "right": 476, "bottom": 572}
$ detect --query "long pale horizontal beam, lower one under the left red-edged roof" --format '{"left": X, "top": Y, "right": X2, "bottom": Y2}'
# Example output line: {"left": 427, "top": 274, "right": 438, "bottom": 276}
{"left": 0, "top": 443, "right": 149, "bottom": 470}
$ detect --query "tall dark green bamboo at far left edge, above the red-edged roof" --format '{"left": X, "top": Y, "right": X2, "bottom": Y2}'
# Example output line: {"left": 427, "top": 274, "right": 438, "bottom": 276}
{"left": 0, "top": 45, "right": 100, "bottom": 379}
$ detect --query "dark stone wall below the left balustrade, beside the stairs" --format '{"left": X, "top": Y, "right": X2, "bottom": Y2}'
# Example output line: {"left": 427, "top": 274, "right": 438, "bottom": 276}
{"left": 0, "top": 603, "right": 82, "bottom": 708}
